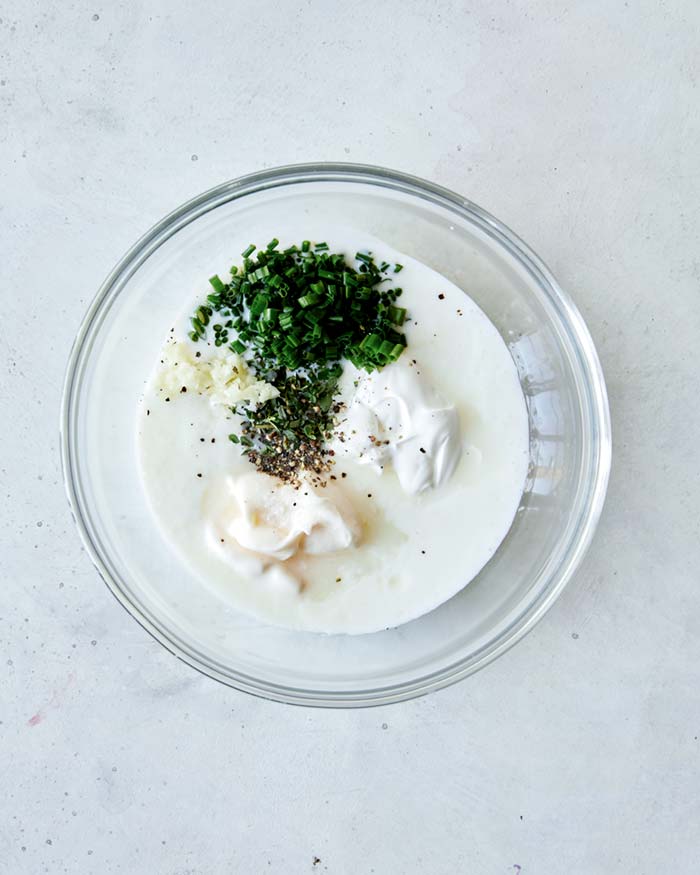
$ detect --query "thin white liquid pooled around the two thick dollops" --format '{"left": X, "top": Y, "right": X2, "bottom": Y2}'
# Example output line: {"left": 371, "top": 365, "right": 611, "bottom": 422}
{"left": 138, "top": 230, "right": 528, "bottom": 633}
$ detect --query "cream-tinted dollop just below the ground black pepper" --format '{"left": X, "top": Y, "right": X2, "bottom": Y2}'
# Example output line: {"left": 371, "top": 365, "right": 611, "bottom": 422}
{"left": 205, "top": 471, "right": 360, "bottom": 581}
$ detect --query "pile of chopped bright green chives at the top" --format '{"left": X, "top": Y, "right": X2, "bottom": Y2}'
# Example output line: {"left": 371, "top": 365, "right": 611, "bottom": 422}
{"left": 193, "top": 245, "right": 406, "bottom": 371}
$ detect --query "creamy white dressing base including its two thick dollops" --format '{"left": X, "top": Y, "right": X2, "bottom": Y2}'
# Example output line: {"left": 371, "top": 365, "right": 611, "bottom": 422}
{"left": 139, "top": 230, "right": 529, "bottom": 633}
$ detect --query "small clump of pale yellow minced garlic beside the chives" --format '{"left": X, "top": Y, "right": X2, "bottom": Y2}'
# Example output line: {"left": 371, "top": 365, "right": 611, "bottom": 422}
{"left": 158, "top": 343, "right": 279, "bottom": 407}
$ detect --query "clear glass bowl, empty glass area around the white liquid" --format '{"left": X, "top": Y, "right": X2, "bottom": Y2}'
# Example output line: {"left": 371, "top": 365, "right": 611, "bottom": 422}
{"left": 61, "top": 164, "right": 611, "bottom": 707}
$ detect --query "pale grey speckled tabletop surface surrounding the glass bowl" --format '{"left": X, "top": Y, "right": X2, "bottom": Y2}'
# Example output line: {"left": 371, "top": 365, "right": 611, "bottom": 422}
{"left": 0, "top": 0, "right": 700, "bottom": 875}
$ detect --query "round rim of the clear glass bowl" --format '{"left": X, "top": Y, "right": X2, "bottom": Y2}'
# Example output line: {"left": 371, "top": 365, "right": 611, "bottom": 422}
{"left": 59, "top": 162, "right": 612, "bottom": 708}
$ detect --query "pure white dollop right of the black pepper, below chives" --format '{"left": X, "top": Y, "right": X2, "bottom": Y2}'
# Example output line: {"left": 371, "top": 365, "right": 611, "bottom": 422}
{"left": 332, "top": 359, "right": 462, "bottom": 495}
